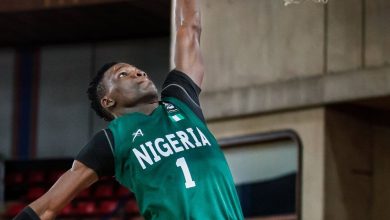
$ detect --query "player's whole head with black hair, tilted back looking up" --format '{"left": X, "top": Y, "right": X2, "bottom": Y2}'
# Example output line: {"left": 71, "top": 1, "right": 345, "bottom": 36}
{"left": 87, "top": 62, "right": 158, "bottom": 121}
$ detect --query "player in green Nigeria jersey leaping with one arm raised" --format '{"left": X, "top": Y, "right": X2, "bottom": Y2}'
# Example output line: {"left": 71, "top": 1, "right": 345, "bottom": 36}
{"left": 15, "top": 0, "right": 243, "bottom": 220}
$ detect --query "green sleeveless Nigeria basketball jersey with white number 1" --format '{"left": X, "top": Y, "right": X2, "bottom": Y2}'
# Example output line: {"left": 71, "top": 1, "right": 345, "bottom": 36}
{"left": 109, "top": 97, "right": 243, "bottom": 220}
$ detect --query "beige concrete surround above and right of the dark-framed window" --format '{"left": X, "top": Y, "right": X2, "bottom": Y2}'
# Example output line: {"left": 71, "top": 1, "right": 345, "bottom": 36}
{"left": 208, "top": 108, "right": 325, "bottom": 220}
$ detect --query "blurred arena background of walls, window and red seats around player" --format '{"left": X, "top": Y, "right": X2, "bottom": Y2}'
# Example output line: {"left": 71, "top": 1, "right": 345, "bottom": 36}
{"left": 0, "top": 0, "right": 390, "bottom": 220}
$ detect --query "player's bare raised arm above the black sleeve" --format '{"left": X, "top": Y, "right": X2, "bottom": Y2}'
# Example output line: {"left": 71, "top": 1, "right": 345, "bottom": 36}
{"left": 174, "top": 0, "right": 204, "bottom": 87}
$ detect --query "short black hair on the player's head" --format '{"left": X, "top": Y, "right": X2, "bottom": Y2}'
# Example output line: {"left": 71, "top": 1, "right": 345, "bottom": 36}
{"left": 87, "top": 62, "right": 119, "bottom": 121}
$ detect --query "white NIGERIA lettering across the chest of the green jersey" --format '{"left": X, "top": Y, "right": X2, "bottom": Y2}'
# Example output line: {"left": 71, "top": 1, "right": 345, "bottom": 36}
{"left": 132, "top": 127, "right": 211, "bottom": 169}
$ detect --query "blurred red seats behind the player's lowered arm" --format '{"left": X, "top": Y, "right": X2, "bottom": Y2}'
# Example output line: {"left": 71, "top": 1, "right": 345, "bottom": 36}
{"left": 0, "top": 159, "right": 139, "bottom": 219}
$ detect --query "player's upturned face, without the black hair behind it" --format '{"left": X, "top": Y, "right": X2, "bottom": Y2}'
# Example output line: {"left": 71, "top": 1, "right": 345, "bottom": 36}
{"left": 103, "top": 63, "right": 158, "bottom": 107}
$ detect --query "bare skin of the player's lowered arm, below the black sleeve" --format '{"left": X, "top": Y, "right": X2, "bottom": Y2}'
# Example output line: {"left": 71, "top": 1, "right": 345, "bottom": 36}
{"left": 14, "top": 160, "right": 98, "bottom": 220}
